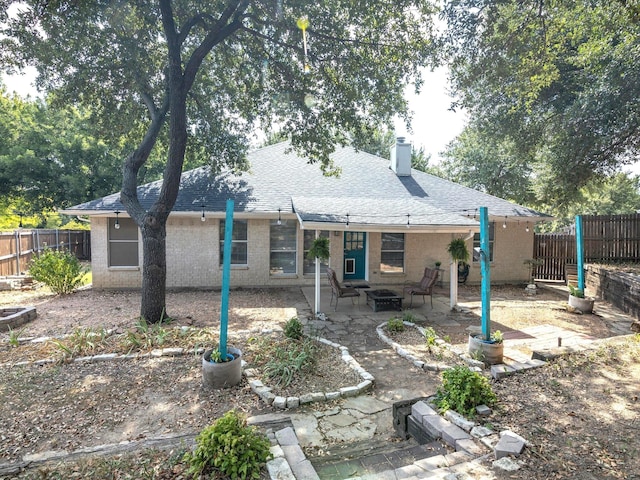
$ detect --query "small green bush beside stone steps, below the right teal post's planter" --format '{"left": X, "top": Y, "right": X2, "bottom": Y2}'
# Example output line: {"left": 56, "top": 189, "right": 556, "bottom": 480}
{"left": 436, "top": 366, "right": 498, "bottom": 417}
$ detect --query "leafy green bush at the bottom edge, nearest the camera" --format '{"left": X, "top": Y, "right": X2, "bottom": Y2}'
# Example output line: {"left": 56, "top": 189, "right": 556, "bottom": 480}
{"left": 184, "top": 410, "right": 271, "bottom": 480}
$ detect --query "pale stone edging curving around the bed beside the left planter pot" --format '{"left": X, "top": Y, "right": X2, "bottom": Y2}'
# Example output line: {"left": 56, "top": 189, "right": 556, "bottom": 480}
{"left": 244, "top": 337, "right": 375, "bottom": 410}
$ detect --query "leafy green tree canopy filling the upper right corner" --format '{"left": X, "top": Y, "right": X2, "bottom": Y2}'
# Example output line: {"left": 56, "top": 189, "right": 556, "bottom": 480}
{"left": 444, "top": 0, "right": 640, "bottom": 203}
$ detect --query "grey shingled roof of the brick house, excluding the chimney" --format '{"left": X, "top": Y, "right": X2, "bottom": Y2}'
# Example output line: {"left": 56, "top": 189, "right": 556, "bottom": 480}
{"left": 63, "top": 142, "right": 550, "bottom": 231}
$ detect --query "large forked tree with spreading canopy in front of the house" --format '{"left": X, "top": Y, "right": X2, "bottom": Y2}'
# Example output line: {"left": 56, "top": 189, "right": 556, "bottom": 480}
{"left": 0, "top": 0, "right": 434, "bottom": 322}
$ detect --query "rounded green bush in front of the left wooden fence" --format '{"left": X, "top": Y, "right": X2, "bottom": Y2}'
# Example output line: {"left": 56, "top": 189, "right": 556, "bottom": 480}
{"left": 29, "top": 248, "right": 85, "bottom": 295}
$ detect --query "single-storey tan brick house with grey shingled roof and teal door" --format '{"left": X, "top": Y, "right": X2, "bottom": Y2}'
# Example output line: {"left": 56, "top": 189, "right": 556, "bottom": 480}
{"left": 64, "top": 139, "right": 548, "bottom": 288}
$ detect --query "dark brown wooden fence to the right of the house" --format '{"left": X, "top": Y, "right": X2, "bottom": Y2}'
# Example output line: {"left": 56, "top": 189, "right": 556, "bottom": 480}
{"left": 533, "top": 214, "right": 640, "bottom": 280}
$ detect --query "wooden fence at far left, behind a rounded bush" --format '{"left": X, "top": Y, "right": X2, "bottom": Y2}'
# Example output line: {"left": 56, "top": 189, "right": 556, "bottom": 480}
{"left": 0, "top": 229, "right": 91, "bottom": 276}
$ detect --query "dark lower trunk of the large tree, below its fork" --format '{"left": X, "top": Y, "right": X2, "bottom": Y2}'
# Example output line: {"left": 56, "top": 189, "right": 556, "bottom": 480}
{"left": 140, "top": 214, "right": 168, "bottom": 323}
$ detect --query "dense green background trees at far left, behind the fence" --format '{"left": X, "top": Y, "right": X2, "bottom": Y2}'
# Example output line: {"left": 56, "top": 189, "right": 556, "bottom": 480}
{"left": 0, "top": 86, "right": 129, "bottom": 223}
